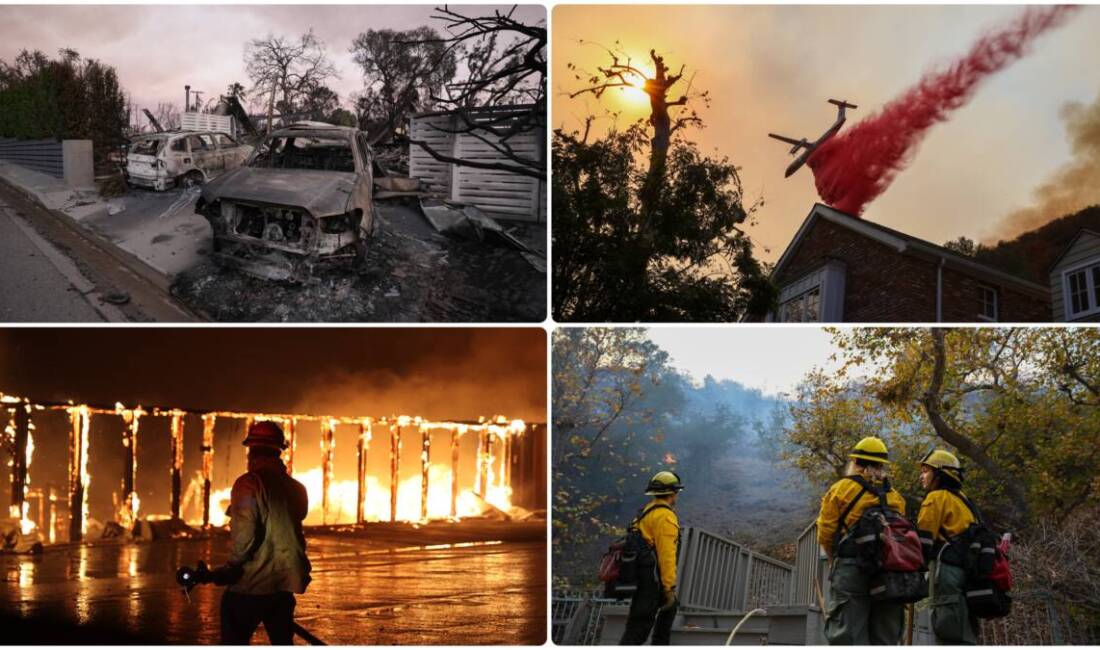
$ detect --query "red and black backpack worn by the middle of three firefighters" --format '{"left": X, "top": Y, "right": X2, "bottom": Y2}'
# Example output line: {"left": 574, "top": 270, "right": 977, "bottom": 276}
{"left": 834, "top": 476, "right": 928, "bottom": 604}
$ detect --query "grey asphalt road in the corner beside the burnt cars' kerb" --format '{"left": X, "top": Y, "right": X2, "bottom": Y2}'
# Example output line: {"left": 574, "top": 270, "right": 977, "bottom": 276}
{"left": 0, "top": 196, "right": 107, "bottom": 322}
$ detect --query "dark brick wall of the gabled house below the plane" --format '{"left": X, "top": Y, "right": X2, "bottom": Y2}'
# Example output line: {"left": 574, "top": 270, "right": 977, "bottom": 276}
{"left": 774, "top": 219, "right": 1051, "bottom": 322}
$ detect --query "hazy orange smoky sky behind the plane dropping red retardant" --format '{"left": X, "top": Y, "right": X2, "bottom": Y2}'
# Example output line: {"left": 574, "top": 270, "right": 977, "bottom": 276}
{"left": 551, "top": 4, "right": 1100, "bottom": 262}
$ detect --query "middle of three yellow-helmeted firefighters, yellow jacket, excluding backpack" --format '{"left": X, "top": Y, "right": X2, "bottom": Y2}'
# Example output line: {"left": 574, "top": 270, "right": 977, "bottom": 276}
{"left": 817, "top": 437, "right": 905, "bottom": 646}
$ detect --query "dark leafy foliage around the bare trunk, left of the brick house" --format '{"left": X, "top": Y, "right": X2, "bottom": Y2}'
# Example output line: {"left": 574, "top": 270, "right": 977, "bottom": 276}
{"left": 552, "top": 125, "right": 776, "bottom": 321}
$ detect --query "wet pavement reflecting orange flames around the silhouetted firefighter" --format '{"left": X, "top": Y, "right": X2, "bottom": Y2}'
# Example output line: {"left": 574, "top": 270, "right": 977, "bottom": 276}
{"left": 0, "top": 533, "right": 547, "bottom": 646}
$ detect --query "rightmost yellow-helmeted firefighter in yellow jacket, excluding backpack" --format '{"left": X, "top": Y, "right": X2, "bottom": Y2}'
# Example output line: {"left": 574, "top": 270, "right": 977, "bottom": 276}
{"left": 916, "top": 449, "right": 978, "bottom": 646}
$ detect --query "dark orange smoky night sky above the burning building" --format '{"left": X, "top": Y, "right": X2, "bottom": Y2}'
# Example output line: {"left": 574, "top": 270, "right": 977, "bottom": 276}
{"left": 0, "top": 328, "right": 547, "bottom": 422}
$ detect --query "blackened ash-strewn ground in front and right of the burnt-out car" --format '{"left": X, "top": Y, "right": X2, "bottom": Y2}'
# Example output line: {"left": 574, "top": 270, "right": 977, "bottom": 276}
{"left": 172, "top": 205, "right": 546, "bottom": 322}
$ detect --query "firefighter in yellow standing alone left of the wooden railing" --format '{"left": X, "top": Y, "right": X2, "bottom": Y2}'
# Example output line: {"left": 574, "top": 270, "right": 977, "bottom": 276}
{"left": 619, "top": 470, "right": 684, "bottom": 646}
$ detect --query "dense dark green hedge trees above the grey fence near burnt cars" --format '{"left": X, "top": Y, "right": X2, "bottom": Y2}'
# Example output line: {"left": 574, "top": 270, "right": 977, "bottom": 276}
{"left": 0, "top": 49, "right": 129, "bottom": 163}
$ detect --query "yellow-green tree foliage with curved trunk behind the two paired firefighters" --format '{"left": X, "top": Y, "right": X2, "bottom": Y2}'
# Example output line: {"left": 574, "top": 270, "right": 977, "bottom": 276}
{"left": 791, "top": 328, "right": 1100, "bottom": 530}
